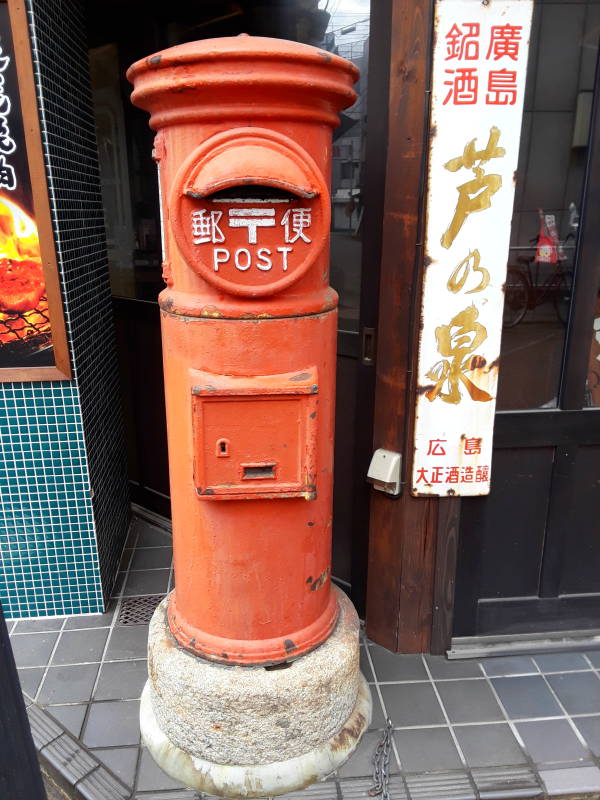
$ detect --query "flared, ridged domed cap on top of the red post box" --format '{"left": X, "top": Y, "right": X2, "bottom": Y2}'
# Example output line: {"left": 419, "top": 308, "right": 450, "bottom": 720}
{"left": 127, "top": 34, "right": 359, "bottom": 130}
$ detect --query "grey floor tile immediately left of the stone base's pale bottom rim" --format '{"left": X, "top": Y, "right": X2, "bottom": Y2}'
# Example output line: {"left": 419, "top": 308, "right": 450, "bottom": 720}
{"left": 82, "top": 700, "right": 140, "bottom": 747}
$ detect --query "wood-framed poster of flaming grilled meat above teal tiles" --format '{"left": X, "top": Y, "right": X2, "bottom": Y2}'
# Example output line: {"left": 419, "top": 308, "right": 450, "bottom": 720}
{"left": 0, "top": 0, "right": 71, "bottom": 381}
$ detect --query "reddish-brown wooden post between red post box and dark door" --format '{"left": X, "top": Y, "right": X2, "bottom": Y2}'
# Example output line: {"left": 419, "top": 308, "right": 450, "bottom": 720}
{"left": 364, "top": 0, "right": 459, "bottom": 653}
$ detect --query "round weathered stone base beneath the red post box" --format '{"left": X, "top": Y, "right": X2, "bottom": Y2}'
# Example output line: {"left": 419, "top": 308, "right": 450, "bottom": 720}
{"left": 140, "top": 590, "right": 371, "bottom": 798}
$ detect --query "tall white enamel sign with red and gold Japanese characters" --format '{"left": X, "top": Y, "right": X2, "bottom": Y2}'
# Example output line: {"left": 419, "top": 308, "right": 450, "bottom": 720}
{"left": 412, "top": 0, "right": 533, "bottom": 496}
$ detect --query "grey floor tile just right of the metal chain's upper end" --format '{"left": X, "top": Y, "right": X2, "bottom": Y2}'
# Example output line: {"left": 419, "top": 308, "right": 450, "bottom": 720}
{"left": 394, "top": 728, "right": 463, "bottom": 772}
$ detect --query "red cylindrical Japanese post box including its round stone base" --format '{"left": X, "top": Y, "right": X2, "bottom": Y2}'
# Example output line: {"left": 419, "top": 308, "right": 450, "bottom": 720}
{"left": 128, "top": 35, "right": 370, "bottom": 795}
